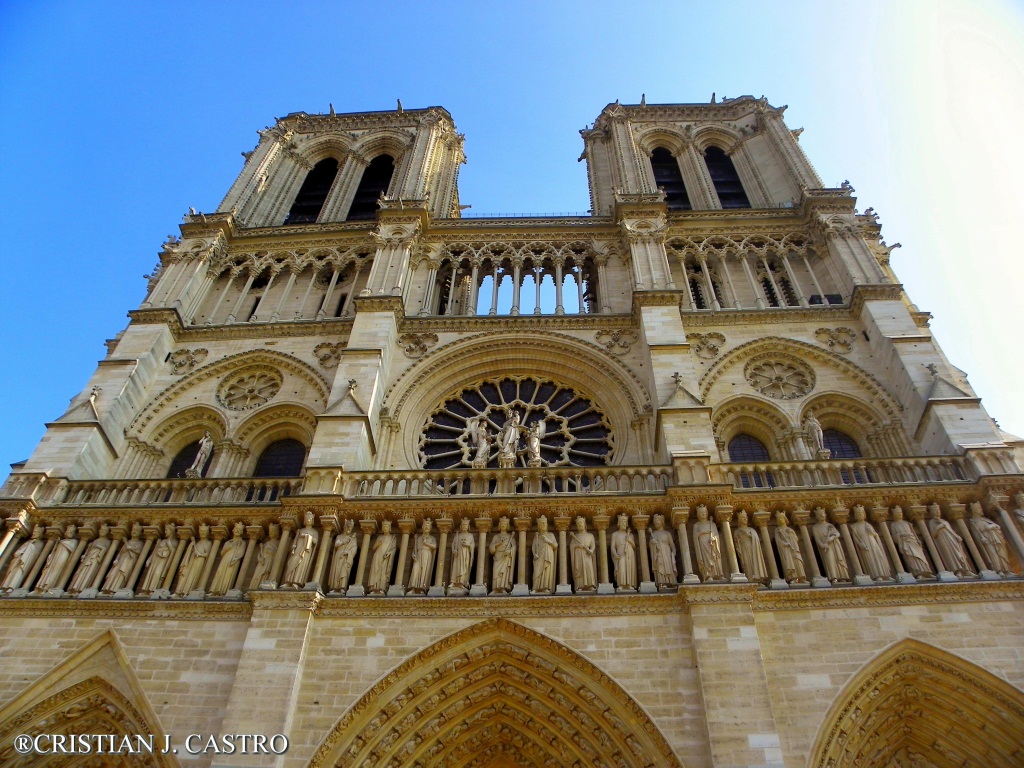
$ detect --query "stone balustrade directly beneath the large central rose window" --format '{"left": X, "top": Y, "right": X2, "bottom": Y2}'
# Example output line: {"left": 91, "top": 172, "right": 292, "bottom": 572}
{"left": 303, "top": 467, "right": 672, "bottom": 499}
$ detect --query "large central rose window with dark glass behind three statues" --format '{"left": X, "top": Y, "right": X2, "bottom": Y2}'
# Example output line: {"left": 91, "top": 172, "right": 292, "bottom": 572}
{"left": 419, "top": 377, "right": 614, "bottom": 469}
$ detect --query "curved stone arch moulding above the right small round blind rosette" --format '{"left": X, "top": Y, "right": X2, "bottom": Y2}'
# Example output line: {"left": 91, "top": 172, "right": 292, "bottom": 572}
{"left": 700, "top": 336, "right": 902, "bottom": 422}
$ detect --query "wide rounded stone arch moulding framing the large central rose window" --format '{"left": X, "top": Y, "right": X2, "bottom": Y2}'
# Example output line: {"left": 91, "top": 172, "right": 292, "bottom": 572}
{"left": 382, "top": 331, "right": 651, "bottom": 467}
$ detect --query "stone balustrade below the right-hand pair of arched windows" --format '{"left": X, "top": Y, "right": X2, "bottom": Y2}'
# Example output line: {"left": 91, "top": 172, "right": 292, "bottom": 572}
{"left": 709, "top": 456, "right": 976, "bottom": 488}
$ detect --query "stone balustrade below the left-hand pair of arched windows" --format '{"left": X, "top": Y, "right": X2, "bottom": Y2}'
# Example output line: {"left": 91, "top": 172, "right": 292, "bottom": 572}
{"left": 56, "top": 477, "right": 302, "bottom": 507}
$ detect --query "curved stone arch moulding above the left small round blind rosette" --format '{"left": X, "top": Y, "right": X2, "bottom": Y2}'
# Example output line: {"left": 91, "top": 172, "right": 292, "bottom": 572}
{"left": 125, "top": 349, "right": 331, "bottom": 437}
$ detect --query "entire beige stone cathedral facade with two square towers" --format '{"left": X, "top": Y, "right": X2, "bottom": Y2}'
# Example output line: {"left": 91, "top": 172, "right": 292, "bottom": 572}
{"left": 0, "top": 96, "right": 1024, "bottom": 768}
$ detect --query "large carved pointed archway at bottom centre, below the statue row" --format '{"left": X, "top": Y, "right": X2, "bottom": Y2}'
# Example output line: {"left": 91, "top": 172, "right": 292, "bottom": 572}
{"left": 309, "top": 618, "right": 682, "bottom": 768}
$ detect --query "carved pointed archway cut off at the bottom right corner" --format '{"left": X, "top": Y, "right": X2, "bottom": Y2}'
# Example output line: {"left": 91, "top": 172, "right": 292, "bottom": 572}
{"left": 808, "top": 639, "right": 1024, "bottom": 768}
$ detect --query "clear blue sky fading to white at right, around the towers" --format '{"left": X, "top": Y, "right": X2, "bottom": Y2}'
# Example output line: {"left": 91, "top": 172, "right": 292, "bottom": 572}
{"left": 0, "top": 0, "right": 1024, "bottom": 468}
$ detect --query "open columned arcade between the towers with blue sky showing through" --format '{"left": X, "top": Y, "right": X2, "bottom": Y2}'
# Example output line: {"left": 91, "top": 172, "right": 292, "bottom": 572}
{"left": 426, "top": 247, "right": 599, "bottom": 315}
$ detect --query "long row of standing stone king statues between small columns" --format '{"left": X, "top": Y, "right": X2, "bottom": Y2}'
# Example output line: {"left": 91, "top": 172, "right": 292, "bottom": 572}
{"left": 0, "top": 494, "right": 1024, "bottom": 599}
